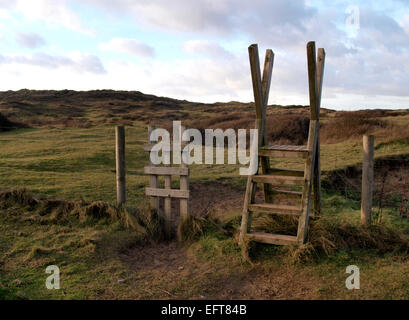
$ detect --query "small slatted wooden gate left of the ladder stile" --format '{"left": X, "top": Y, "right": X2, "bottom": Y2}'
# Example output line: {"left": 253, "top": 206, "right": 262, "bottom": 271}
{"left": 144, "top": 126, "right": 189, "bottom": 238}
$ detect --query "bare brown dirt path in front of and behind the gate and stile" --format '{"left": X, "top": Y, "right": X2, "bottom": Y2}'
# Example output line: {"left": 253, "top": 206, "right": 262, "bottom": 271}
{"left": 116, "top": 184, "right": 319, "bottom": 299}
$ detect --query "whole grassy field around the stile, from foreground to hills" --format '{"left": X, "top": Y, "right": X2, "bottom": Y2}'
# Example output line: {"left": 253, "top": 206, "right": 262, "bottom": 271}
{"left": 0, "top": 90, "right": 409, "bottom": 299}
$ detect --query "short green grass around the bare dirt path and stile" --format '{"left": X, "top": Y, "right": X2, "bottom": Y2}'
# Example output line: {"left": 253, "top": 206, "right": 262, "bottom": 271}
{"left": 0, "top": 124, "right": 409, "bottom": 299}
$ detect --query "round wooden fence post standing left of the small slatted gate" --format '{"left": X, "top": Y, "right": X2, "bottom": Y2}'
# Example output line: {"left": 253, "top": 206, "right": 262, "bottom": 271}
{"left": 115, "top": 126, "right": 126, "bottom": 205}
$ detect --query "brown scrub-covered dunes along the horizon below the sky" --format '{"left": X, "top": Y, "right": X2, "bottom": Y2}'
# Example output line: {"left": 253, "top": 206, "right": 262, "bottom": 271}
{"left": 0, "top": 90, "right": 409, "bottom": 151}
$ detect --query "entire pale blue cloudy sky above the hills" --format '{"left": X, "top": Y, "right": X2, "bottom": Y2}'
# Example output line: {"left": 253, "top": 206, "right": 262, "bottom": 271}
{"left": 0, "top": 0, "right": 409, "bottom": 110}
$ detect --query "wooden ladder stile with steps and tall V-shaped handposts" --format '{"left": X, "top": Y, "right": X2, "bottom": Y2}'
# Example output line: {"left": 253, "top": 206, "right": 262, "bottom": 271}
{"left": 239, "top": 41, "right": 325, "bottom": 248}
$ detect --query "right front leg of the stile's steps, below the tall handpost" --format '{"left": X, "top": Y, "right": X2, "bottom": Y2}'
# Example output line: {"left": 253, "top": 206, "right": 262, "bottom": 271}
{"left": 297, "top": 120, "right": 318, "bottom": 244}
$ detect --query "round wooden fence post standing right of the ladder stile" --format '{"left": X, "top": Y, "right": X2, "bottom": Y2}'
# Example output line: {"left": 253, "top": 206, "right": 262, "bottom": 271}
{"left": 361, "top": 135, "right": 374, "bottom": 224}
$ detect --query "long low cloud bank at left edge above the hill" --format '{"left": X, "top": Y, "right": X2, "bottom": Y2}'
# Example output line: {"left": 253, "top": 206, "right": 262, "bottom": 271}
{"left": 0, "top": 53, "right": 106, "bottom": 74}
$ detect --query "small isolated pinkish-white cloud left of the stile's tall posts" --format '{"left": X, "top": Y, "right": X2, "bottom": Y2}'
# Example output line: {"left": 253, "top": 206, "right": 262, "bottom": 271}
{"left": 99, "top": 38, "right": 155, "bottom": 58}
